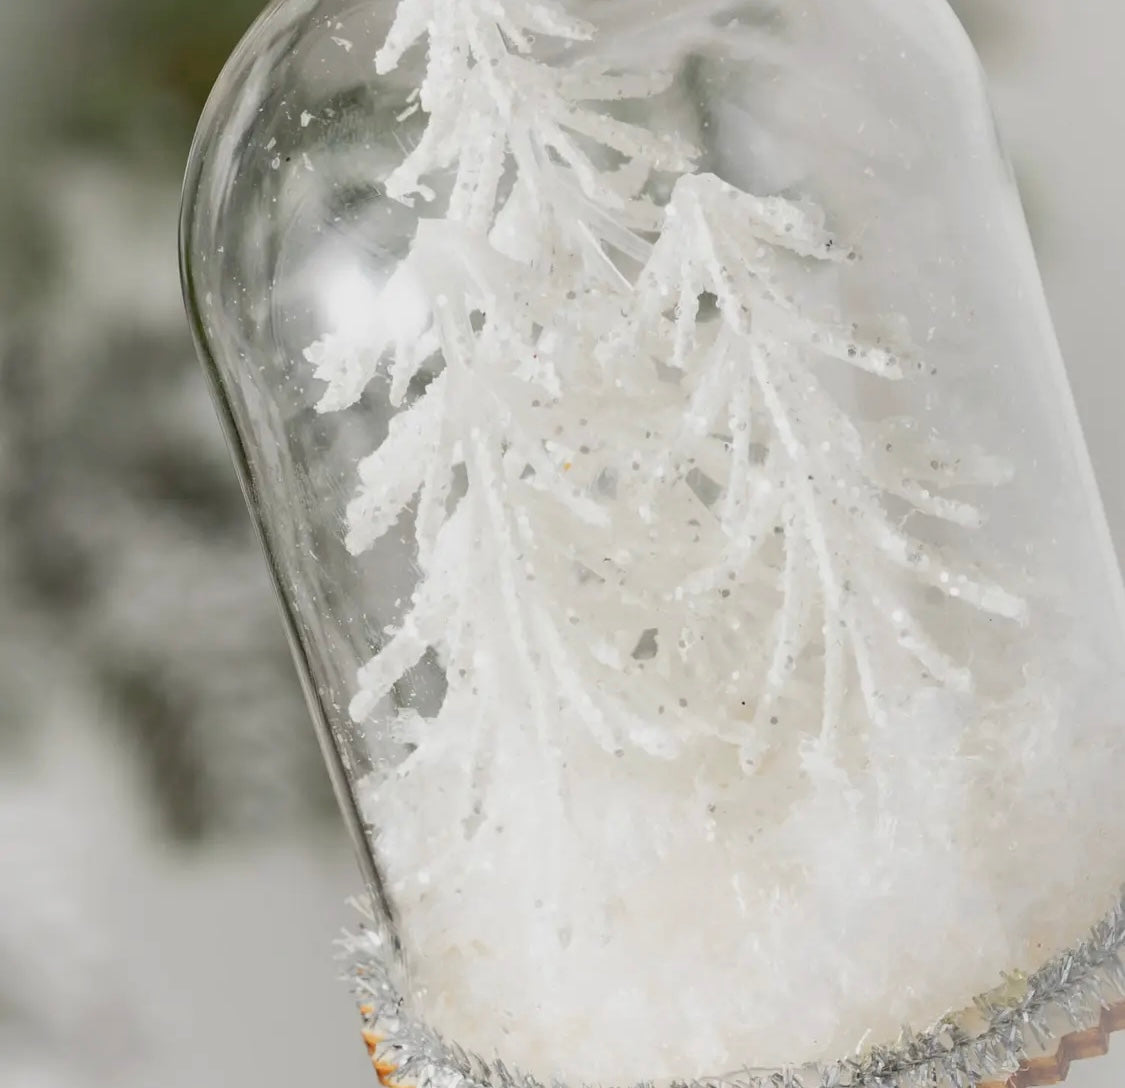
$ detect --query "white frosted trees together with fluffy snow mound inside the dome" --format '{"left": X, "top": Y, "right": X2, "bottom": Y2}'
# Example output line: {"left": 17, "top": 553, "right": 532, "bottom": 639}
{"left": 290, "top": 0, "right": 1125, "bottom": 1079}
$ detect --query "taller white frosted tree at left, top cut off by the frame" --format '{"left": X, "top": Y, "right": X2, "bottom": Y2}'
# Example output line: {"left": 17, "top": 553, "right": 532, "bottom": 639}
{"left": 307, "top": 0, "right": 715, "bottom": 783}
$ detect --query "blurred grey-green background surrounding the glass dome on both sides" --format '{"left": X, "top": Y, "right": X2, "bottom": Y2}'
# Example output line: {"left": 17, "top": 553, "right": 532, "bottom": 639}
{"left": 0, "top": 0, "right": 1125, "bottom": 1088}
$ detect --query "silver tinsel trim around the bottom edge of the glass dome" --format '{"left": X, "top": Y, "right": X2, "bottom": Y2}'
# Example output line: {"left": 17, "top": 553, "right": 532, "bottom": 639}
{"left": 341, "top": 890, "right": 1125, "bottom": 1088}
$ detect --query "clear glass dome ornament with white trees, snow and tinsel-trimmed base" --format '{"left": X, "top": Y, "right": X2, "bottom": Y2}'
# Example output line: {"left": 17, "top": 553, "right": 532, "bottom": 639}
{"left": 182, "top": 0, "right": 1125, "bottom": 1088}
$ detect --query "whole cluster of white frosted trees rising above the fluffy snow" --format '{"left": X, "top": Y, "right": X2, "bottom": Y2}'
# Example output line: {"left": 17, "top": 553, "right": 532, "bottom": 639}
{"left": 308, "top": 0, "right": 1024, "bottom": 792}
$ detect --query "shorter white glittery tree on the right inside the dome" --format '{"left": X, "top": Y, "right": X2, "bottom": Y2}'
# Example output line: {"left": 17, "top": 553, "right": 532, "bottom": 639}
{"left": 601, "top": 174, "right": 1026, "bottom": 763}
